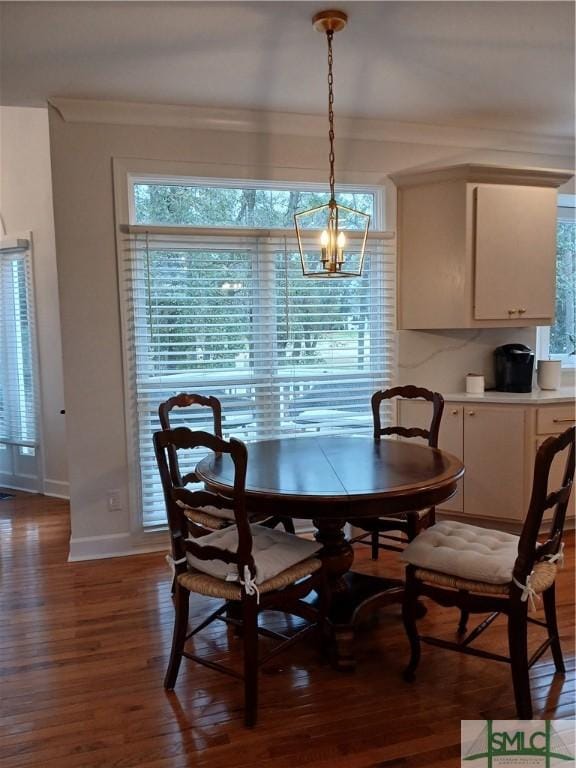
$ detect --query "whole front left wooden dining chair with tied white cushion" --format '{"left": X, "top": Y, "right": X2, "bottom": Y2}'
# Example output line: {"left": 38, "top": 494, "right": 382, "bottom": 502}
{"left": 154, "top": 427, "right": 329, "bottom": 726}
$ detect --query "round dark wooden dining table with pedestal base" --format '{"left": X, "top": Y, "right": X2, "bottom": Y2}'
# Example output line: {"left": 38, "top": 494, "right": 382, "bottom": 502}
{"left": 196, "top": 435, "right": 464, "bottom": 669}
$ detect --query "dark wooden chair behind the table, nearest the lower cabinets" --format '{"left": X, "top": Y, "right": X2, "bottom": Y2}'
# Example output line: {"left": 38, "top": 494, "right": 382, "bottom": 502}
{"left": 349, "top": 385, "right": 444, "bottom": 560}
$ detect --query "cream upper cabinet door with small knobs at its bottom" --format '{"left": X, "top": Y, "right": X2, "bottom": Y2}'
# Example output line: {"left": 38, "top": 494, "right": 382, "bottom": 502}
{"left": 474, "top": 185, "right": 556, "bottom": 321}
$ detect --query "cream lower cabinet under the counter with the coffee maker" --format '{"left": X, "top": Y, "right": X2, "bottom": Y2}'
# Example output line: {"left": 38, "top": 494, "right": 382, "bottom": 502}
{"left": 398, "top": 400, "right": 576, "bottom": 529}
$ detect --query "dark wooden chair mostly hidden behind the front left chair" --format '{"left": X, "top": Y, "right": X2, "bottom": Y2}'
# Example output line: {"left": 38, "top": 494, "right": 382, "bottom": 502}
{"left": 158, "top": 392, "right": 294, "bottom": 536}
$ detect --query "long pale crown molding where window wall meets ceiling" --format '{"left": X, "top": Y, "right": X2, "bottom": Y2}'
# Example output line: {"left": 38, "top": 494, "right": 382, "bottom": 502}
{"left": 49, "top": 96, "right": 574, "bottom": 157}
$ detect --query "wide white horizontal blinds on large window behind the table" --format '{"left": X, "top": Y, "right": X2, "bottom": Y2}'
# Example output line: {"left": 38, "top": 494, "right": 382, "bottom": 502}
{"left": 121, "top": 227, "right": 395, "bottom": 525}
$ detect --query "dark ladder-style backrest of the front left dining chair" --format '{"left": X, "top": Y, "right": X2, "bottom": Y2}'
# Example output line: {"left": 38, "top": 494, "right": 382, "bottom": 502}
{"left": 154, "top": 427, "right": 255, "bottom": 576}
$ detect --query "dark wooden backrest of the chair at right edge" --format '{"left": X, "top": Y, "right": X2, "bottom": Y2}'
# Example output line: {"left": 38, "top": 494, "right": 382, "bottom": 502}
{"left": 514, "top": 427, "right": 576, "bottom": 584}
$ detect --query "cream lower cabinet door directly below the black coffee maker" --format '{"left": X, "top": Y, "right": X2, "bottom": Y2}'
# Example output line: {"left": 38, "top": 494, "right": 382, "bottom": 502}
{"left": 464, "top": 405, "right": 526, "bottom": 520}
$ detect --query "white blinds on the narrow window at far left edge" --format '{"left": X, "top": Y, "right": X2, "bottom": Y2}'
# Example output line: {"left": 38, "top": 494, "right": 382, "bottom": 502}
{"left": 0, "top": 238, "right": 38, "bottom": 447}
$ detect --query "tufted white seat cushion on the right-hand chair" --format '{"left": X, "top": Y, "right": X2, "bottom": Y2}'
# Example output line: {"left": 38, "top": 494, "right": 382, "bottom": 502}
{"left": 401, "top": 520, "right": 519, "bottom": 584}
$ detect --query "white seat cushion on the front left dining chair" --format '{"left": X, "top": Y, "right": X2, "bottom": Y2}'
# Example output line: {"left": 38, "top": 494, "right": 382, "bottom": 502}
{"left": 187, "top": 525, "right": 322, "bottom": 584}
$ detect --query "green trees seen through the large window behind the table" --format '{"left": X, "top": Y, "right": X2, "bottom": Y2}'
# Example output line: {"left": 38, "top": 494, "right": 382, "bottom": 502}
{"left": 134, "top": 184, "right": 373, "bottom": 373}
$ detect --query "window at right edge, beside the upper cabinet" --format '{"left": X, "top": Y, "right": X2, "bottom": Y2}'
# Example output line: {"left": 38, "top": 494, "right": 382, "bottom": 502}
{"left": 539, "top": 195, "right": 576, "bottom": 367}
